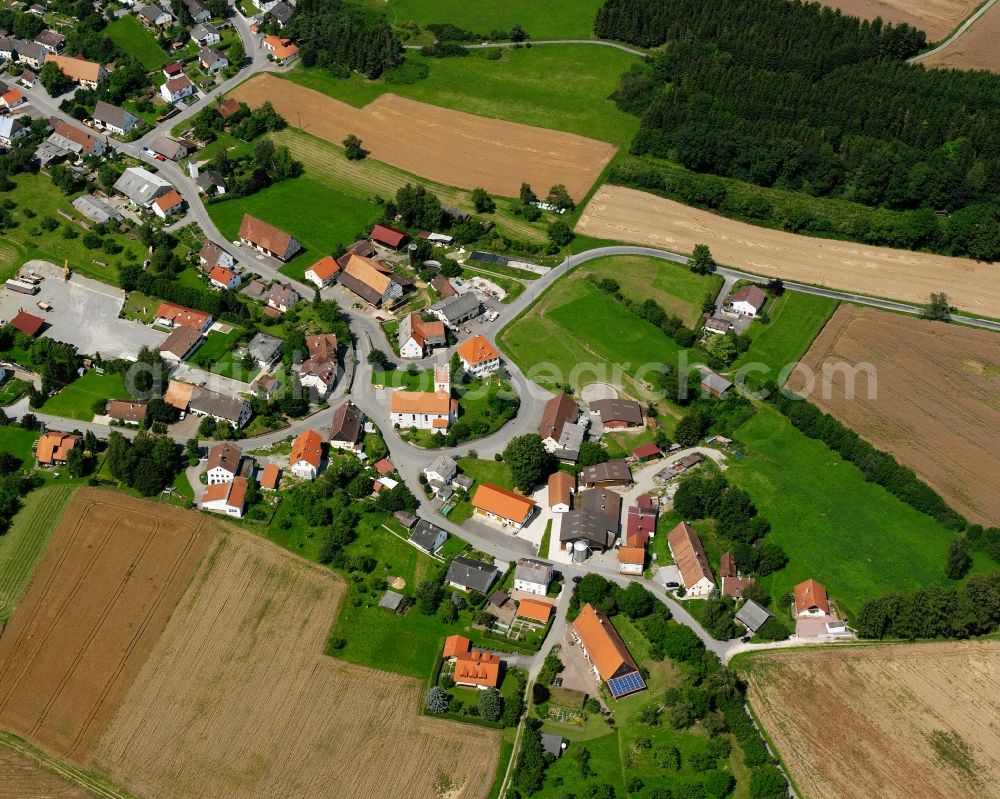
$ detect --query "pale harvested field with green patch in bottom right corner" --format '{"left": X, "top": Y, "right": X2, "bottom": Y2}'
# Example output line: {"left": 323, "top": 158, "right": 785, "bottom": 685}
{"left": 741, "top": 641, "right": 1000, "bottom": 799}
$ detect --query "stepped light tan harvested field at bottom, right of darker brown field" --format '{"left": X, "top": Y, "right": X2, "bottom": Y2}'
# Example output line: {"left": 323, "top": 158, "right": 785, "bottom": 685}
{"left": 94, "top": 531, "right": 500, "bottom": 799}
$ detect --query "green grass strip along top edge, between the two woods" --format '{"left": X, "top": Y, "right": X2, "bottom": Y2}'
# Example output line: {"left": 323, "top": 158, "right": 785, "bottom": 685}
{"left": 363, "top": 0, "right": 601, "bottom": 44}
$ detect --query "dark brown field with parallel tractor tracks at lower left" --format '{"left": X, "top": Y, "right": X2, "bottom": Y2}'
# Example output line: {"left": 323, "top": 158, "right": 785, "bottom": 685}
{"left": 0, "top": 489, "right": 210, "bottom": 760}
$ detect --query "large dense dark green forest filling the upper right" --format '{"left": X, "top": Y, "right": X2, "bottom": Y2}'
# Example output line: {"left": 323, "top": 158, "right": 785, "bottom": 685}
{"left": 595, "top": 0, "right": 1000, "bottom": 260}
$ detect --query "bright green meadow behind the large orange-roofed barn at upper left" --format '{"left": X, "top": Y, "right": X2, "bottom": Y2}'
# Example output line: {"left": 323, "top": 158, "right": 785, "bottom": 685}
{"left": 207, "top": 173, "right": 380, "bottom": 280}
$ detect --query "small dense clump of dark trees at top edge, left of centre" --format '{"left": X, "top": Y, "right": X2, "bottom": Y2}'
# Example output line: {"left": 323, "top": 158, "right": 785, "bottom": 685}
{"left": 282, "top": 0, "right": 403, "bottom": 78}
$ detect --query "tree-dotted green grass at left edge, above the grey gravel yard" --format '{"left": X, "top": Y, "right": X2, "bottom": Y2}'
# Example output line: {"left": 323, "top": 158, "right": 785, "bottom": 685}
{"left": 0, "top": 173, "right": 146, "bottom": 285}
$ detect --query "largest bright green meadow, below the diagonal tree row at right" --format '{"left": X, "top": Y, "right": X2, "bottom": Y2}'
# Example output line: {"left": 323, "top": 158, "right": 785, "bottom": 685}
{"left": 732, "top": 407, "right": 964, "bottom": 619}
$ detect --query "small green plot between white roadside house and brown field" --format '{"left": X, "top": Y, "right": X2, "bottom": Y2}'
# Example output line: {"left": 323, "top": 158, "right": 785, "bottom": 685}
{"left": 731, "top": 291, "right": 838, "bottom": 384}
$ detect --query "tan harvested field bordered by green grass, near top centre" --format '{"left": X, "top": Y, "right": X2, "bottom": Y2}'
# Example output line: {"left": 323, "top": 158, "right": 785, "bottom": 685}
{"left": 229, "top": 74, "right": 615, "bottom": 200}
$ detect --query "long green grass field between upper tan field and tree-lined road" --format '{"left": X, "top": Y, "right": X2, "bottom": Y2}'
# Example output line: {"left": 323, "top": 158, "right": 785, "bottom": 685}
{"left": 281, "top": 44, "right": 639, "bottom": 147}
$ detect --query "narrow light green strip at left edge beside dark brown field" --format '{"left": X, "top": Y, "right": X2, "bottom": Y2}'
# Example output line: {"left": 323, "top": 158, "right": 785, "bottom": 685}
{"left": 0, "top": 484, "right": 76, "bottom": 621}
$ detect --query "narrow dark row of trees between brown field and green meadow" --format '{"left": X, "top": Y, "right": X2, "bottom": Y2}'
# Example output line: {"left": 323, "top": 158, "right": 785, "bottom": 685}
{"left": 765, "top": 383, "right": 966, "bottom": 530}
